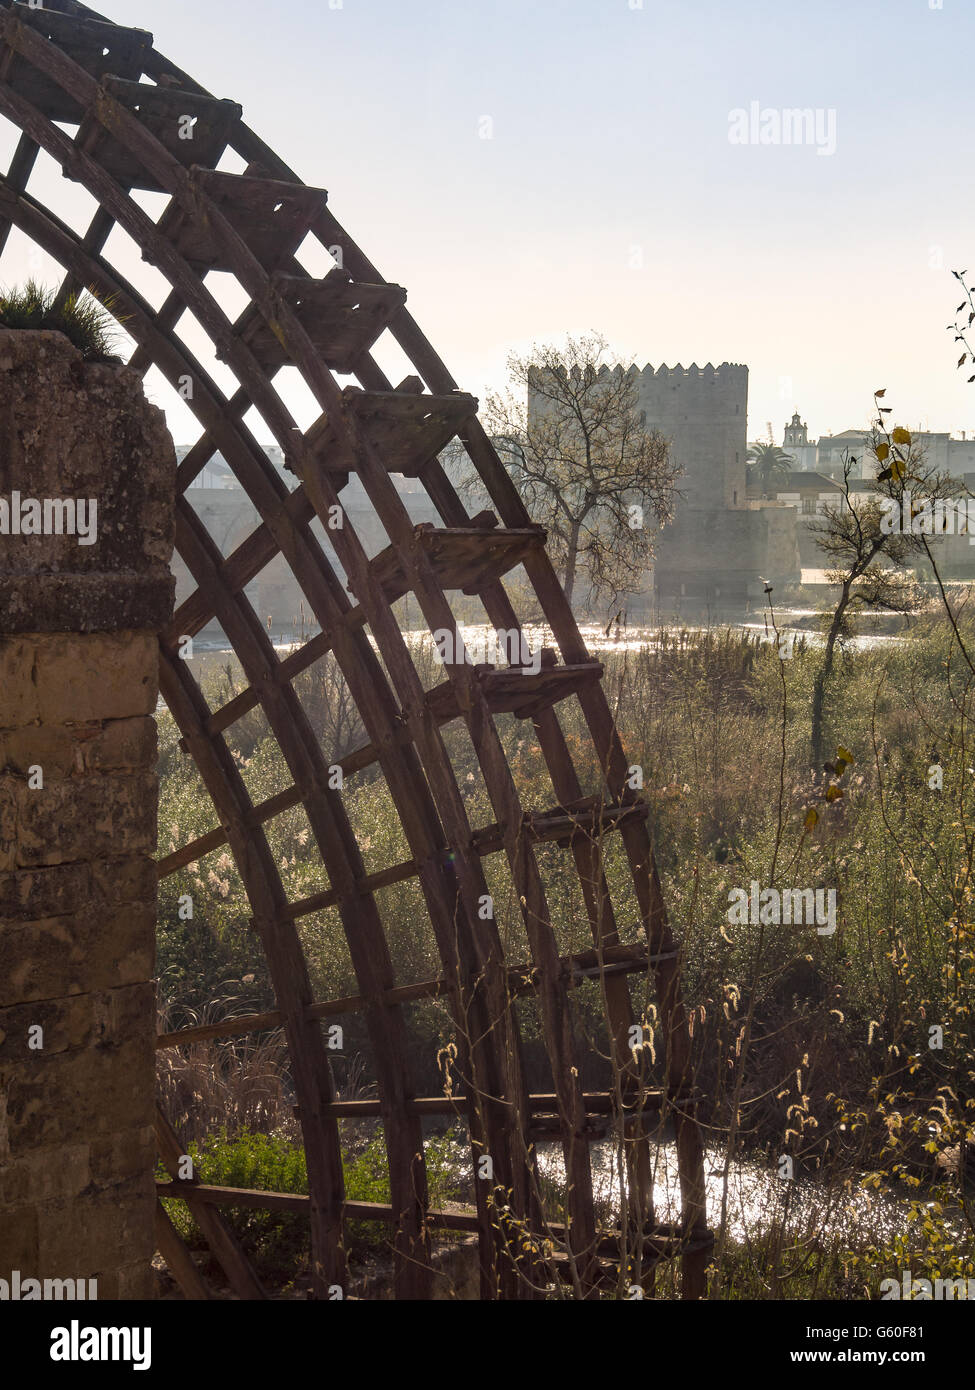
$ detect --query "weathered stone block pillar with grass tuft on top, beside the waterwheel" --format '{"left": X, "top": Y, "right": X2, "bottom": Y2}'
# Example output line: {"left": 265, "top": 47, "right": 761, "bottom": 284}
{"left": 0, "top": 329, "right": 175, "bottom": 1298}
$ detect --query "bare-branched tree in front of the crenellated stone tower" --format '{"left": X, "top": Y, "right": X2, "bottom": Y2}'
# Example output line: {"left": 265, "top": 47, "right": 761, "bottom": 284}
{"left": 485, "top": 335, "right": 680, "bottom": 602}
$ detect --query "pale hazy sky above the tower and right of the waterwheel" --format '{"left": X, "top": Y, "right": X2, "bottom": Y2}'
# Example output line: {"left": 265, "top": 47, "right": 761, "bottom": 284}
{"left": 3, "top": 0, "right": 975, "bottom": 441}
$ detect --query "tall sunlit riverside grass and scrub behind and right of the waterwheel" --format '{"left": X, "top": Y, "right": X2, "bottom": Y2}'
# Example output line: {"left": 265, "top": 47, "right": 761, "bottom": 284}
{"left": 160, "top": 613, "right": 975, "bottom": 1297}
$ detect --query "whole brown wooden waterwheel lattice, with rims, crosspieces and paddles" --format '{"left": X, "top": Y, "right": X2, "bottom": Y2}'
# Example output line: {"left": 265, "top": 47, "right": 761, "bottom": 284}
{"left": 0, "top": 0, "right": 711, "bottom": 1298}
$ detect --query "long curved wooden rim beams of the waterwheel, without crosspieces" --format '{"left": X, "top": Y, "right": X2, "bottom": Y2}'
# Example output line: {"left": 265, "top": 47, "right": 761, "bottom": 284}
{"left": 0, "top": 0, "right": 704, "bottom": 1297}
